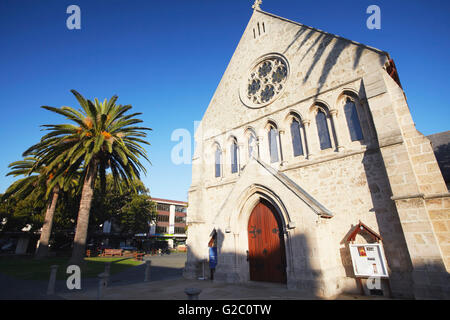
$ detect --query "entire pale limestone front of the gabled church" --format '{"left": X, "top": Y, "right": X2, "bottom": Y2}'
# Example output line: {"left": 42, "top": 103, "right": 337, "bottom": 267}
{"left": 184, "top": 6, "right": 450, "bottom": 298}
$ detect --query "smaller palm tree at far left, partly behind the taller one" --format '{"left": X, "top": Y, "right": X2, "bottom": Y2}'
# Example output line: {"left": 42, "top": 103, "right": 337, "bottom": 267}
{"left": 3, "top": 157, "right": 76, "bottom": 259}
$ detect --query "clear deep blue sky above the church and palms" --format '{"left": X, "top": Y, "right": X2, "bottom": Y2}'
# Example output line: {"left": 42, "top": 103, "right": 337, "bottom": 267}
{"left": 0, "top": 0, "right": 450, "bottom": 201}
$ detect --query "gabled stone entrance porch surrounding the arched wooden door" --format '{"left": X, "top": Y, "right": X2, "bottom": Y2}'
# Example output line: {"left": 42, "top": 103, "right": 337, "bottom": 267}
{"left": 185, "top": 158, "right": 325, "bottom": 292}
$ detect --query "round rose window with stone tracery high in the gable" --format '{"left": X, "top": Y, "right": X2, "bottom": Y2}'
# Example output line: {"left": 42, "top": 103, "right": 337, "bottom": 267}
{"left": 241, "top": 55, "right": 289, "bottom": 108}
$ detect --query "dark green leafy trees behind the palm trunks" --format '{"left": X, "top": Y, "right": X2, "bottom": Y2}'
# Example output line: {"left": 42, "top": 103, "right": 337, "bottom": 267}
{"left": 0, "top": 175, "right": 157, "bottom": 233}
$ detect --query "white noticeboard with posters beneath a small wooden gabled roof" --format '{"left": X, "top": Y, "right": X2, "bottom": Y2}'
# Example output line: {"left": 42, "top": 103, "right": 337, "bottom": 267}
{"left": 349, "top": 243, "right": 388, "bottom": 278}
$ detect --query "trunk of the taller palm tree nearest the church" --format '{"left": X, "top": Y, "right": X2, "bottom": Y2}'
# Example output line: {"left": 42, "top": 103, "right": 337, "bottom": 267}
{"left": 69, "top": 161, "right": 97, "bottom": 266}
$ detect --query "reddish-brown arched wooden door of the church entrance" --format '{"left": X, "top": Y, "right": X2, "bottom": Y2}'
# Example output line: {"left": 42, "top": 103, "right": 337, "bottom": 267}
{"left": 248, "top": 201, "right": 286, "bottom": 283}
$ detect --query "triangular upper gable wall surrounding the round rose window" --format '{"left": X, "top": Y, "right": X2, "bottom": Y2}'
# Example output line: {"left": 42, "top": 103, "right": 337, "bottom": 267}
{"left": 198, "top": 11, "right": 387, "bottom": 140}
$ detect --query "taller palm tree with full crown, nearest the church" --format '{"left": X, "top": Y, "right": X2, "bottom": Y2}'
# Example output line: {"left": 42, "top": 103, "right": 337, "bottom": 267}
{"left": 24, "top": 90, "right": 151, "bottom": 265}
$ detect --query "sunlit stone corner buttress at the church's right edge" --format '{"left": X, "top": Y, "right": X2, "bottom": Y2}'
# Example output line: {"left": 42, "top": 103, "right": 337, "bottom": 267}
{"left": 364, "top": 72, "right": 450, "bottom": 298}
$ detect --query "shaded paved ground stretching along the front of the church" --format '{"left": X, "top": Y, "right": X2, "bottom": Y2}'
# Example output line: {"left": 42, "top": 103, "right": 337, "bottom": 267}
{"left": 0, "top": 253, "right": 390, "bottom": 300}
